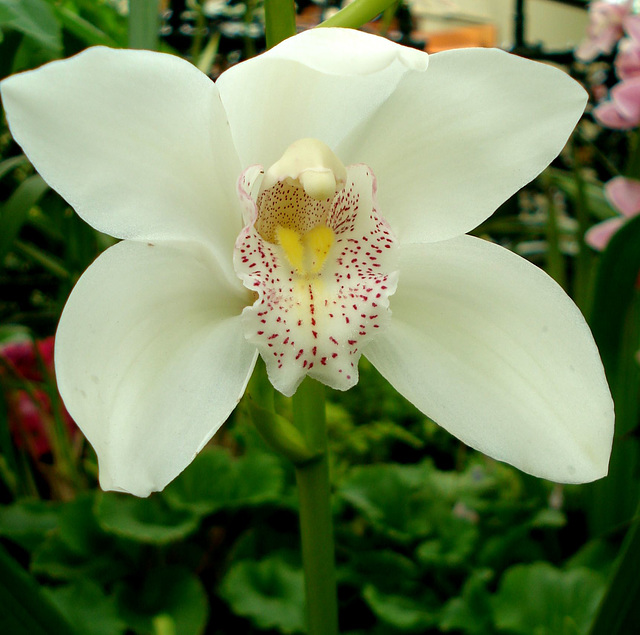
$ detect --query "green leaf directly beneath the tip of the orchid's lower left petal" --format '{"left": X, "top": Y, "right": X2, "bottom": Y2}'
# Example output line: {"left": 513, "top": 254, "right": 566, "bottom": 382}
{"left": 95, "top": 492, "right": 199, "bottom": 545}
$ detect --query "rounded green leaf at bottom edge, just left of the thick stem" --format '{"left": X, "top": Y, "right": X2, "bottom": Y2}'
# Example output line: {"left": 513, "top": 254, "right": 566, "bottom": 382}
{"left": 219, "top": 555, "right": 305, "bottom": 633}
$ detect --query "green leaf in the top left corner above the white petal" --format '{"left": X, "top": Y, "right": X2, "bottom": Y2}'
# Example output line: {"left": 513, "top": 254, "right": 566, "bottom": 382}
{"left": 0, "top": 0, "right": 62, "bottom": 54}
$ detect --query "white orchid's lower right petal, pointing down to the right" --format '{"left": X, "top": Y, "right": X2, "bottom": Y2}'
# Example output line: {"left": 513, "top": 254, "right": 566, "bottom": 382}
{"left": 364, "top": 236, "right": 613, "bottom": 483}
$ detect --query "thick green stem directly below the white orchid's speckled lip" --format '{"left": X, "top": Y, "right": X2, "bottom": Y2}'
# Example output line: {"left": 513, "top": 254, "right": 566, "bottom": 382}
{"left": 293, "top": 378, "right": 338, "bottom": 635}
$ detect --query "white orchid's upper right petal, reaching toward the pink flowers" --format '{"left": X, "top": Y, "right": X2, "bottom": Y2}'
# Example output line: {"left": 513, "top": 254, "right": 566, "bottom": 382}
{"left": 335, "top": 49, "right": 587, "bottom": 242}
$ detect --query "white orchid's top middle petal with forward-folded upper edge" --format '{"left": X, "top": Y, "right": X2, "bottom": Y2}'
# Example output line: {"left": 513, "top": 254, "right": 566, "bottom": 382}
{"left": 216, "top": 28, "right": 428, "bottom": 168}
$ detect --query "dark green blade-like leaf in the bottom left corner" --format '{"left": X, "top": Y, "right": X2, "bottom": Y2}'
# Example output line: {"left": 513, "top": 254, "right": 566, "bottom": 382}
{"left": 0, "top": 546, "right": 77, "bottom": 635}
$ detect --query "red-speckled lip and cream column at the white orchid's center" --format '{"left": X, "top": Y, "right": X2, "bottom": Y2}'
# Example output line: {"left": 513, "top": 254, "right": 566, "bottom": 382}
{"left": 234, "top": 139, "right": 397, "bottom": 395}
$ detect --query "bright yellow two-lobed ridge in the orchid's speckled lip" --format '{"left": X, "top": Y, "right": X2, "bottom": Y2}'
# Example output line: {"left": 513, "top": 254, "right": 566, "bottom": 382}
{"left": 276, "top": 225, "right": 335, "bottom": 278}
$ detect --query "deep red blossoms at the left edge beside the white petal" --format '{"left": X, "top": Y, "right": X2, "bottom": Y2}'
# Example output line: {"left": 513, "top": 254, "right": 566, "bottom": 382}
{"left": 0, "top": 337, "right": 77, "bottom": 460}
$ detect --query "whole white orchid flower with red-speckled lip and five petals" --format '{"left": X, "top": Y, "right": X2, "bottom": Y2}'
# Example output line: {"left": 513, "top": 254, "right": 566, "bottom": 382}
{"left": 2, "top": 29, "right": 613, "bottom": 496}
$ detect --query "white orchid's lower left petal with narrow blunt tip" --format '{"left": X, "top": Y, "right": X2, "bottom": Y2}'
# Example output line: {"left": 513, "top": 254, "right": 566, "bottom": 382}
{"left": 55, "top": 241, "right": 256, "bottom": 496}
